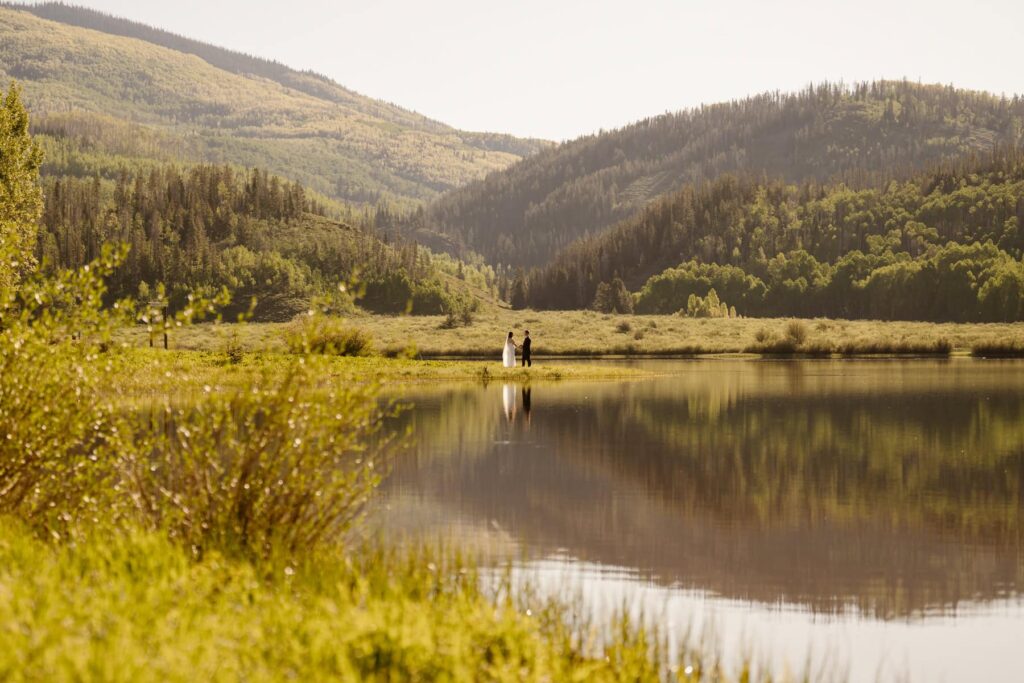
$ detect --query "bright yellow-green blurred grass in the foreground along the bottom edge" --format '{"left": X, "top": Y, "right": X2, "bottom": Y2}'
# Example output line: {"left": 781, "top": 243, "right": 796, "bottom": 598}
{"left": 0, "top": 518, "right": 716, "bottom": 681}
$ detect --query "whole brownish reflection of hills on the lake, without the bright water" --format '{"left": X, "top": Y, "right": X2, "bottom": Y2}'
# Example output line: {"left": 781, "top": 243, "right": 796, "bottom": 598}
{"left": 380, "top": 362, "right": 1024, "bottom": 615}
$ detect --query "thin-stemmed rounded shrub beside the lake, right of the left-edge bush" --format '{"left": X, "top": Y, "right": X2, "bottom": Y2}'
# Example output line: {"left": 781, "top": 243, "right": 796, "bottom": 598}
{"left": 124, "top": 357, "right": 395, "bottom": 557}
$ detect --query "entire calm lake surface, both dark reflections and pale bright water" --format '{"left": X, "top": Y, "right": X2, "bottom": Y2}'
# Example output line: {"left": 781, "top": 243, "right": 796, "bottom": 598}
{"left": 376, "top": 359, "right": 1024, "bottom": 682}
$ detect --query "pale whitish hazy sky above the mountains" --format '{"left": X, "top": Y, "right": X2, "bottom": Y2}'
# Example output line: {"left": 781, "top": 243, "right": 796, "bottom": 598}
{"left": 24, "top": 0, "right": 1024, "bottom": 139}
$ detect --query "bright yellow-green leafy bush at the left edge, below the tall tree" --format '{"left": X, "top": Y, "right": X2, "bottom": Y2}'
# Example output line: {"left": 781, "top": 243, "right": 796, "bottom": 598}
{"left": 0, "top": 242, "right": 125, "bottom": 533}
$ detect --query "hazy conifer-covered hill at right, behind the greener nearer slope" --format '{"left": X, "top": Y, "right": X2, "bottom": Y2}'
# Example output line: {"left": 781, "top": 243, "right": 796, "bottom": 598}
{"left": 412, "top": 82, "right": 1024, "bottom": 266}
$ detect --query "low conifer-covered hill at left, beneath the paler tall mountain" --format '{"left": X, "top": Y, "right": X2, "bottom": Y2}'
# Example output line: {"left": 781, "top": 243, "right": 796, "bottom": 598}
{"left": 37, "top": 160, "right": 495, "bottom": 321}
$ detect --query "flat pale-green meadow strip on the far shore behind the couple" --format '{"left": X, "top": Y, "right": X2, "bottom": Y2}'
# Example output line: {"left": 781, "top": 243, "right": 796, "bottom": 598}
{"left": 116, "top": 310, "right": 1024, "bottom": 361}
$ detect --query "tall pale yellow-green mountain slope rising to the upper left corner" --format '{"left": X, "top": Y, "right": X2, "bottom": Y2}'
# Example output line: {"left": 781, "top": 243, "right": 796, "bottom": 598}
{"left": 0, "top": 3, "right": 547, "bottom": 206}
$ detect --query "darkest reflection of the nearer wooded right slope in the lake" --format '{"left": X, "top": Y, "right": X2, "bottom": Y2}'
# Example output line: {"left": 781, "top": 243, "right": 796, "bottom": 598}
{"left": 614, "top": 385, "right": 1024, "bottom": 539}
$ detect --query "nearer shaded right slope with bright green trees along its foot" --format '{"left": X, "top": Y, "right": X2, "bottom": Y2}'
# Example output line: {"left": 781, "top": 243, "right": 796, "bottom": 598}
{"left": 519, "top": 148, "right": 1024, "bottom": 321}
